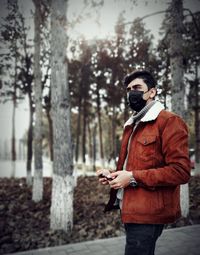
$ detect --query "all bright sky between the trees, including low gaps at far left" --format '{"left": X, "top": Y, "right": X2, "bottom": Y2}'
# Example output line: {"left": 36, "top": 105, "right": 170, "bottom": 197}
{"left": 0, "top": 0, "right": 200, "bottom": 139}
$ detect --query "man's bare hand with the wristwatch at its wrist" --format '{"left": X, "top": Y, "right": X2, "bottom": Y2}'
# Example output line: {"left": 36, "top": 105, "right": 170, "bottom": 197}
{"left": 109, "top": 170, "right": 133, "bottom": 189}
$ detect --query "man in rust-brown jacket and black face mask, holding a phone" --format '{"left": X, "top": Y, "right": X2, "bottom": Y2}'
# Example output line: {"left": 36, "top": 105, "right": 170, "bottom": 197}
{"left": 97, "top": 71, "right": 190, "bottom": 255}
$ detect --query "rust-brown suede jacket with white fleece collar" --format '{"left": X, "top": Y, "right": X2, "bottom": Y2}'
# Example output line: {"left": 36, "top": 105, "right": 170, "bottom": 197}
{"left": 105, "top": 102, "right": 190, "bottom": 224}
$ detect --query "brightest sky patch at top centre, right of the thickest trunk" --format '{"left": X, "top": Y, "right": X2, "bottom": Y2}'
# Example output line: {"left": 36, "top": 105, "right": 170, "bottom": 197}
{"left": 68, "top": 0, "right": 168, "bottom": 39}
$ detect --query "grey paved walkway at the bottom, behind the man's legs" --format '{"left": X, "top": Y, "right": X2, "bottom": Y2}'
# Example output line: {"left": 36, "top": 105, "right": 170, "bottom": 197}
{"left": 5, "top": 225, "right": 200, "bottom": 255}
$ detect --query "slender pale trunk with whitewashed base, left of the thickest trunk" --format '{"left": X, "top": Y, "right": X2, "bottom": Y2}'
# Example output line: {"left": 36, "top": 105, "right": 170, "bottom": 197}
{"left": 32, "top": 0, "right": 43, "bottom": 202}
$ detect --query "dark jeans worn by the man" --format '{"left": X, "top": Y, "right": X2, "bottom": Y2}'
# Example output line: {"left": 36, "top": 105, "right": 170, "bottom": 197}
{"left": 124, "top": 223, "right": 164, "bottom": 255}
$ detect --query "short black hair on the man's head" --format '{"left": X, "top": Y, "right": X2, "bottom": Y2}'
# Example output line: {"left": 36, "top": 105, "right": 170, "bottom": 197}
{"left": 124, "top": 70, "right": 156, "bottom": 89}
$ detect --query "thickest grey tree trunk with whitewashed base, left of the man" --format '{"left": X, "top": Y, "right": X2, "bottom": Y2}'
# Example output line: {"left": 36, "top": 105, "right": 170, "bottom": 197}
{"left": 50, "top": 0, "right": 74, "bottom": 232}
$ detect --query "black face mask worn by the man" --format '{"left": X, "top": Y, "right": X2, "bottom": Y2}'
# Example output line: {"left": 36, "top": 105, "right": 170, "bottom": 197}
{"left": 127, "top": 90, "right": 148, "bottom": 112}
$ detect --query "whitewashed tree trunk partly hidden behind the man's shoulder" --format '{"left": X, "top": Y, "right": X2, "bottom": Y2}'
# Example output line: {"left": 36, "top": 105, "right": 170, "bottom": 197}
{"left": 170, "top": 0, "right": 189, "bottom": 217}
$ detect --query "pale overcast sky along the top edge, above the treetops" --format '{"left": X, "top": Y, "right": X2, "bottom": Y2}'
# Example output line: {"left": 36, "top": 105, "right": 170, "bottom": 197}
{"left": 0, "top": 0, "right": 200, "bottom": 39}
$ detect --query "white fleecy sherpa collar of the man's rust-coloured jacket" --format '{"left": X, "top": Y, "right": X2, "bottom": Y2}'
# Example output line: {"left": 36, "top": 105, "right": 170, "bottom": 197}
{"left": 124, "top": 101, "right": 164, "bottom": 127}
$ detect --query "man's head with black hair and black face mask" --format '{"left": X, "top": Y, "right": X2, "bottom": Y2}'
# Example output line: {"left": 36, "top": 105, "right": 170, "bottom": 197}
{"left": 124, "top": 70, "right": 156, "bottom": 112}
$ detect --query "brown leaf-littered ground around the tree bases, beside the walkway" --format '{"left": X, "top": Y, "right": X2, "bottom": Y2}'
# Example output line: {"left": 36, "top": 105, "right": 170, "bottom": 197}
{"left": 0, "top": 176, "right": 200, "bottom": 254}
